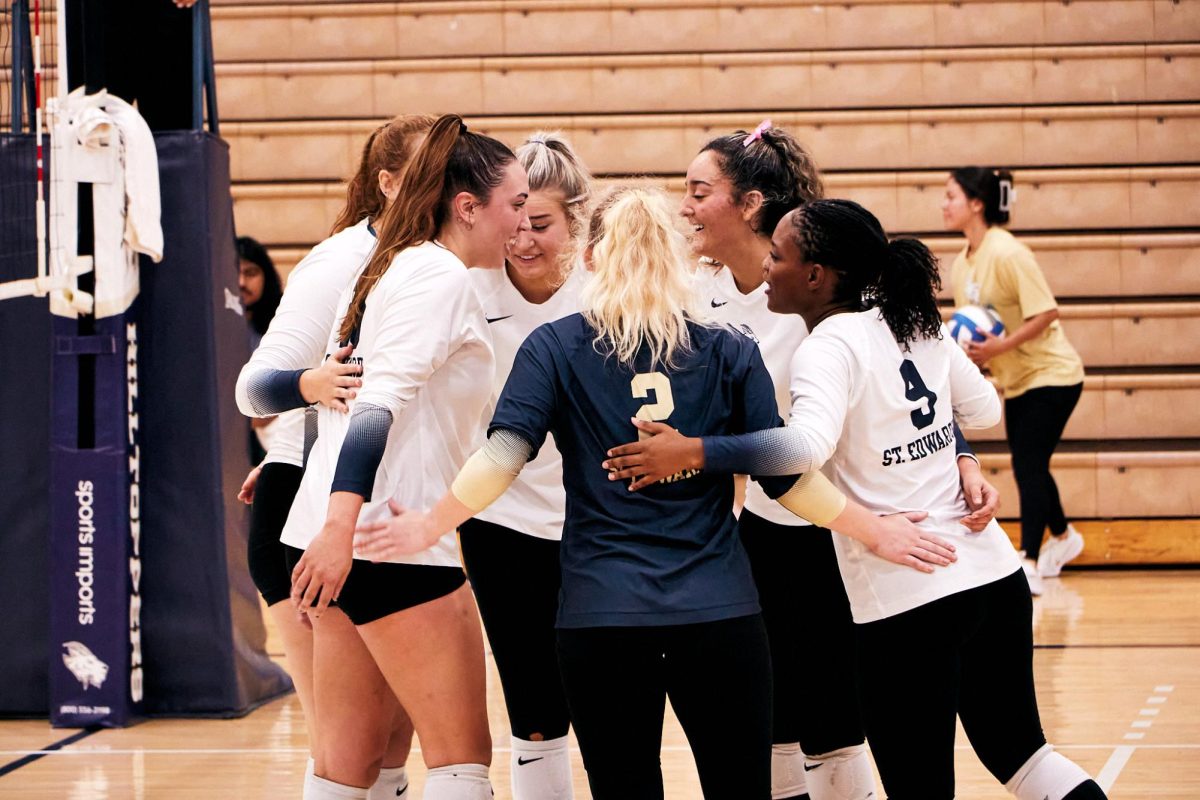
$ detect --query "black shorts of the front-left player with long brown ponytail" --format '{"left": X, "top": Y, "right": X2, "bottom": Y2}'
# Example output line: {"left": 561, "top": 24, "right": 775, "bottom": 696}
{"left": 283, "top": 545, "right": 467, "bottom": 625}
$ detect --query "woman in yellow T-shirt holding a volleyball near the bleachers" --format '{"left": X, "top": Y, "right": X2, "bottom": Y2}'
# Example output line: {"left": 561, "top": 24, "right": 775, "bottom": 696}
{"left": 942, "top": 167, "right": 1084, "bottom": 595}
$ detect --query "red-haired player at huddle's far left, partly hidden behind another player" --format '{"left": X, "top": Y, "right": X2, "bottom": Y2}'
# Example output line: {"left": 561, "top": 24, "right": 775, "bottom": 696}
{"left": 236, "top": 114, "right": 433, "bottom": 800}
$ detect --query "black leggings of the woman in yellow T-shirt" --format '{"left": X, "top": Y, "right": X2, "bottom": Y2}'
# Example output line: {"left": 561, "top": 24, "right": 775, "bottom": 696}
{"left": 1004, "top": 384, "right": 1084, "bottom": 560}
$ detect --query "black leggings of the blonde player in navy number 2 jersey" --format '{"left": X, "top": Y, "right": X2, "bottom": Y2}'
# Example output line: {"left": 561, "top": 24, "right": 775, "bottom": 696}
{"left": 558, "top": 614, "right": 770, "bottom": 800}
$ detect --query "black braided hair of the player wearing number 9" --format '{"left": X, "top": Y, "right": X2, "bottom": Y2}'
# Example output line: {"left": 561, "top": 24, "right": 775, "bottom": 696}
{"left": 792, "top": 200, "right": 942, "bottom": 350}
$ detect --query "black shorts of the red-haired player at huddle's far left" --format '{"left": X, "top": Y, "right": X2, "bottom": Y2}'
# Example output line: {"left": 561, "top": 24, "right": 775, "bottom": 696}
{"left": 246, "top": 462, "right": 304, "bottom": 606}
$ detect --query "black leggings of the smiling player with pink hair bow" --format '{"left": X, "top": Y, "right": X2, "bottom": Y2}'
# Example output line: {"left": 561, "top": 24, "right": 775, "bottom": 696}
{"left": 738, "top": 511, "right": 864, "bottom": 756}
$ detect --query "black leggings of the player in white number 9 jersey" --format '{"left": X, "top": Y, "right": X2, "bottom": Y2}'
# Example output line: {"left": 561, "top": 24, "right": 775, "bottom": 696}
{"left": 856, "top": 570, "right": 1046, "bottom": 800}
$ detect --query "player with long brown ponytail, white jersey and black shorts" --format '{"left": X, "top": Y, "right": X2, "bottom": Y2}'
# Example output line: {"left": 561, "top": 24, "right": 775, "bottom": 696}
{"left": 278, "top": 115, "right": 529, "bottom": 800}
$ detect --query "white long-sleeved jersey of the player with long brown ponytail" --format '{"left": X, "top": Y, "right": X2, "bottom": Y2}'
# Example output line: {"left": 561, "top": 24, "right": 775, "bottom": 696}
{"left": 280, "top": 242, "right": 493, "bottom": 566}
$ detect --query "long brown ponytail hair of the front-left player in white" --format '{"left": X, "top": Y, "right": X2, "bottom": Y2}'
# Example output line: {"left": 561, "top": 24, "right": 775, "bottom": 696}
{"left": 337, "top": 114, "right": 516, "bottom": 342}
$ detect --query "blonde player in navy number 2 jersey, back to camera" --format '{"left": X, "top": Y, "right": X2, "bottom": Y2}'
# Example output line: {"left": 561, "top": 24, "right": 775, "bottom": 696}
{"left": 355, "top": 188, "right": 953, "bottom": 800}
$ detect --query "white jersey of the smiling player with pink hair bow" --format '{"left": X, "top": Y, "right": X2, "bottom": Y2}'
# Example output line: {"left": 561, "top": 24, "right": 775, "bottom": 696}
{"left": 696, "top": 264, "right": 810, "bottom": 525}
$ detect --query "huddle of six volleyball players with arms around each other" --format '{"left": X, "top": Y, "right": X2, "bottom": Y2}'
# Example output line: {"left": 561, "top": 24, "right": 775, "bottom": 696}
{"left": 229, "top": 115, "right": 1105, "bottom": 800}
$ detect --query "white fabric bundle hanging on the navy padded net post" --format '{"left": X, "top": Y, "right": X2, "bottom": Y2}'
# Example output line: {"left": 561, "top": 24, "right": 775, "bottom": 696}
{"left": 49, "top": 89, "right": 163, "bottom": 319}
